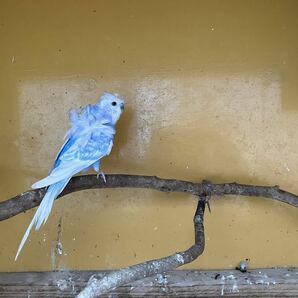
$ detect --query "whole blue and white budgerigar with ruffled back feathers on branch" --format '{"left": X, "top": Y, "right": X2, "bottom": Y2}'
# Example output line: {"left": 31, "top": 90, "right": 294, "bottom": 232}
{"left": 15, "top": 92, "right": 124, "bottom": 259}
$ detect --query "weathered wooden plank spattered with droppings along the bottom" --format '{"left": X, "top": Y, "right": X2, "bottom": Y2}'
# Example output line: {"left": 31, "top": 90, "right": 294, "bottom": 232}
{"left": 0, "top": 268, "right": 298, "bottom": 297}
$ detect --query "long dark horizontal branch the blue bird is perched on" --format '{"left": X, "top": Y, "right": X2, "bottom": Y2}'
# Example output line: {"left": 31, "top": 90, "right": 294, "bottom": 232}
{"left": 0, "top": 174, "right": 298, "bottom": 221}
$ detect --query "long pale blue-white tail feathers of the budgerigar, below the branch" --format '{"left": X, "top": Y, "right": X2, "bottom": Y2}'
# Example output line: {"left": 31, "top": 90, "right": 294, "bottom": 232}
{"left": 15, "top": 178, "right": 70, "bottom": 260}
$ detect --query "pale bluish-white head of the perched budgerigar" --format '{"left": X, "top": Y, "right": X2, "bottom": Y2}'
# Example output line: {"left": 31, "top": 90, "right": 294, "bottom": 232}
{"left": 97, "top": 92, "right": 124, "bottom": 124}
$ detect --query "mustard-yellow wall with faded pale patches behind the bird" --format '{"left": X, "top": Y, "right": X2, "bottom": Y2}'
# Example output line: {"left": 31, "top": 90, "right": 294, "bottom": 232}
{"left": 0, "top": 0, "right": 298, "bottom": 271}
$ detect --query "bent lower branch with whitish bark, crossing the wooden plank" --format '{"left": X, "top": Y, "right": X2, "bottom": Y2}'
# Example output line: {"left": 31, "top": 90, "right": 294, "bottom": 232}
{"left": 78, "top": 198, "right": 205, "bottom": 298}
